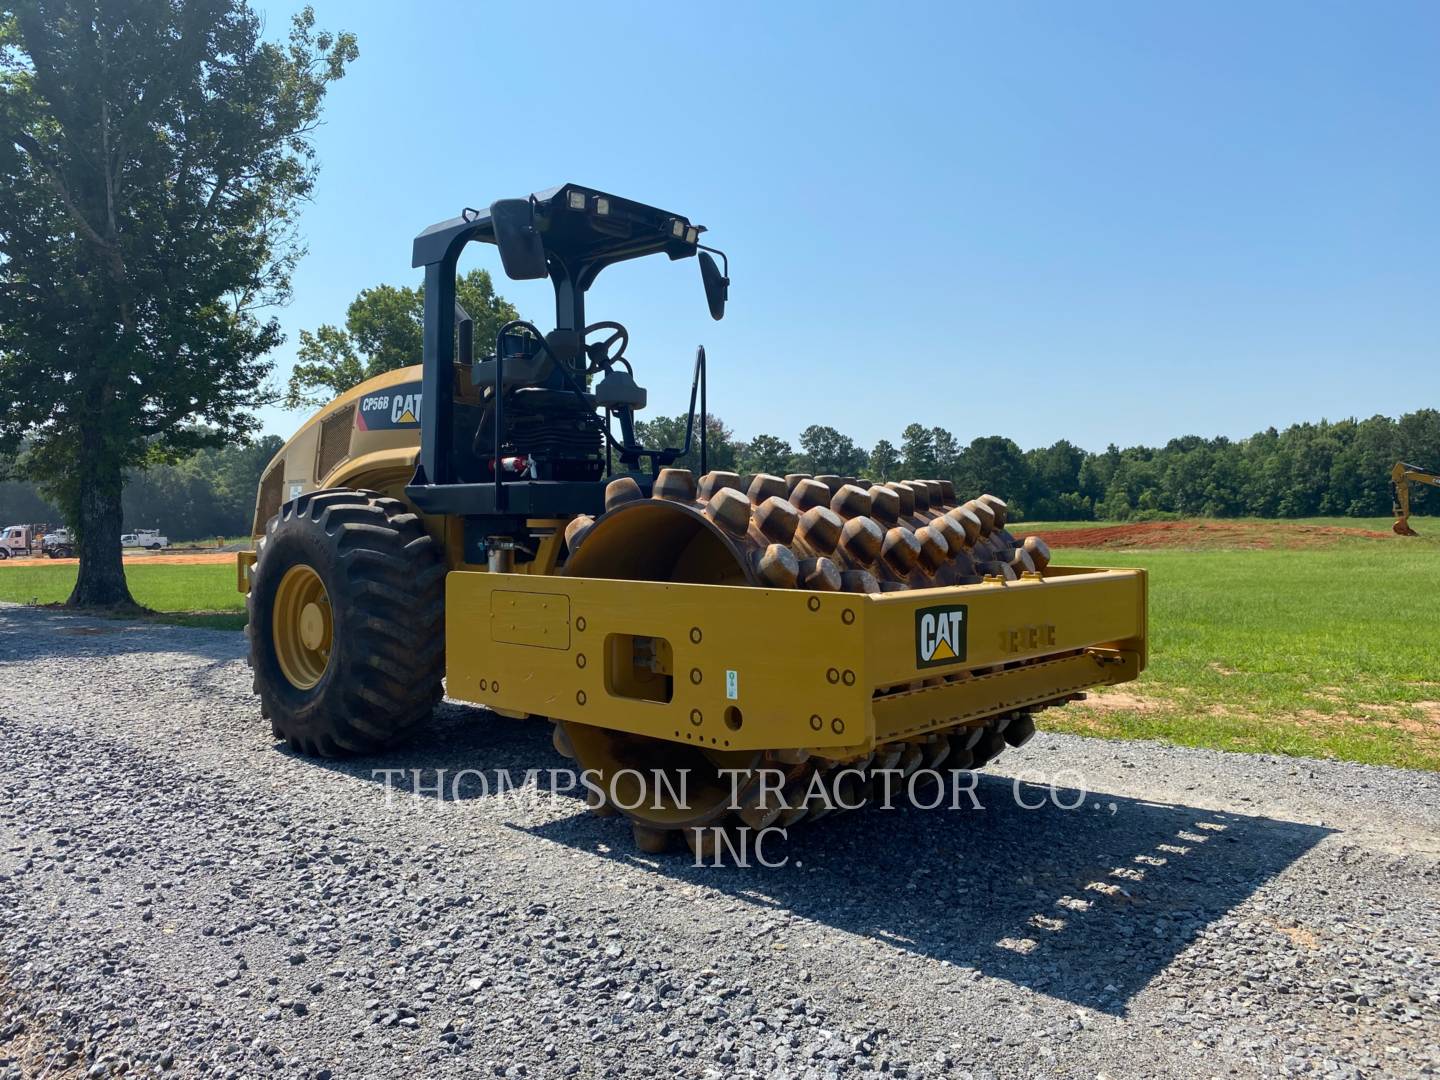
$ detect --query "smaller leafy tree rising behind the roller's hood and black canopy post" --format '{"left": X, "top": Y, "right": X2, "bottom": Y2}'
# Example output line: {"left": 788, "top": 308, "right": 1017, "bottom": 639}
{"left": 285, "top": 269, "right": 520, "bottom": 409}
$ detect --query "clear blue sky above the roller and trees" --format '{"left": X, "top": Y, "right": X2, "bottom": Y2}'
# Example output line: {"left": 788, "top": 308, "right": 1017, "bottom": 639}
{"left": 253, "top": 0, "right": 1440, "bottom": 449}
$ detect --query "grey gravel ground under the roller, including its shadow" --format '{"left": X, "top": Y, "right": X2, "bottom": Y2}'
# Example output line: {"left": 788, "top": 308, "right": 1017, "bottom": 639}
{"left": 0, "top": 606, "right": 1440, "bottom": 1080}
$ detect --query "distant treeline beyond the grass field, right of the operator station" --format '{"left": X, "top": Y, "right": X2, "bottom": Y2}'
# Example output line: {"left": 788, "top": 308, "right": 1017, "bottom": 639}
{"left": 641, "top": 409, "right": 1440, "bottom": 521}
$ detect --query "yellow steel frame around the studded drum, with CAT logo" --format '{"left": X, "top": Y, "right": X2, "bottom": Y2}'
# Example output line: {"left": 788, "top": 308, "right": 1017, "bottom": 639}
{"left": 445, "top": 567, "right": 1146, "bottom": 759}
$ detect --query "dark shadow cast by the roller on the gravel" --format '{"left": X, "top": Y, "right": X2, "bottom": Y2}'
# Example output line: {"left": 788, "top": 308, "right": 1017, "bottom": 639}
{"left": 287, "top": 704, "right": 1332, "bottom": 1015}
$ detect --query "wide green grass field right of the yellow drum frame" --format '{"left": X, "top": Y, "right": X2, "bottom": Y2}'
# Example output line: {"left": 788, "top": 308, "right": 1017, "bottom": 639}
{"left": 1045, "top": 550, "right": 1440, "bottom": 769}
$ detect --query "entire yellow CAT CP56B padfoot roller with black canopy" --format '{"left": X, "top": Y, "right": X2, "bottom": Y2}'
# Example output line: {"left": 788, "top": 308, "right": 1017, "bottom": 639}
{"left": 239, "top": 184, "right": 1146, "bottom": 851}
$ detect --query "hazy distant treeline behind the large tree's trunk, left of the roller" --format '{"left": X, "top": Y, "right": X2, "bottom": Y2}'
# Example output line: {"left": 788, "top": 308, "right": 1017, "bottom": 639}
{"left": 0, "top": 435, "right": 284, "bottom": 541}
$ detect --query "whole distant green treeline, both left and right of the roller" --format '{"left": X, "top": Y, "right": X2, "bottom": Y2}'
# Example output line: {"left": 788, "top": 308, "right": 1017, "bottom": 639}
{"left": 8, "top": 409, "right": 1440, "bottom": 540}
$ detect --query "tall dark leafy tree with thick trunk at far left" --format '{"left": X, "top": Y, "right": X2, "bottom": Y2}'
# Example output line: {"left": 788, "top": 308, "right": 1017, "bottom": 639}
{"left": 0, "top": 0, "right": 357, "bottom": 605}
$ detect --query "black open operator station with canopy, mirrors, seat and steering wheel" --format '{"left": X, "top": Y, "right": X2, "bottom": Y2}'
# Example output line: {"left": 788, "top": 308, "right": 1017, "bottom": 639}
{"left": 406, "top": 184, "right": 730, "bottom": 533}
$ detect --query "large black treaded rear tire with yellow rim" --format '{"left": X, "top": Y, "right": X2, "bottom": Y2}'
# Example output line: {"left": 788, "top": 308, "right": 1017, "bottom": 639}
{"left": 245, "top": 488, "right": 445, "bottom": 757}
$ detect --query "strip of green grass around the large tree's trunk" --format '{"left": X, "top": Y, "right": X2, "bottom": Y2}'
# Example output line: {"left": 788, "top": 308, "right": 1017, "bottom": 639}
{"left": 0, "top": 563, "right": 245, "bottom": 629}
